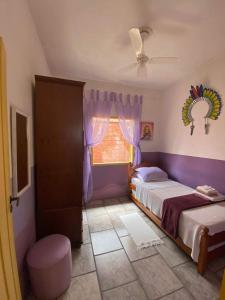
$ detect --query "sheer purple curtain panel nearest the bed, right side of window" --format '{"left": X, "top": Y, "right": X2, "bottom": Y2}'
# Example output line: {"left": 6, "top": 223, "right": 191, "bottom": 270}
{"left": 115, "top": 94, "right": 142, "bottom": 165}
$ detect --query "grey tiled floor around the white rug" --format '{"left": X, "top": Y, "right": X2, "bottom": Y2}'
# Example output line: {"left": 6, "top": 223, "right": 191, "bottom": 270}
{"left": 28, "top": 197, "right": 225, "bottom": 300}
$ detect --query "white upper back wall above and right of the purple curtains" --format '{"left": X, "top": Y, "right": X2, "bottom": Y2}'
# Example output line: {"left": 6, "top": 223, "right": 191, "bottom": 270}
{"left": 85, "top": 81, "right": 160, "bottom": 152}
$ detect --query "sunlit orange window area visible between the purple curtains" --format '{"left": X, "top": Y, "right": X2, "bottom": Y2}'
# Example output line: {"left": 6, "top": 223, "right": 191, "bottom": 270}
{"left": 92, "top": 118, "right": 133, "bottom": 165}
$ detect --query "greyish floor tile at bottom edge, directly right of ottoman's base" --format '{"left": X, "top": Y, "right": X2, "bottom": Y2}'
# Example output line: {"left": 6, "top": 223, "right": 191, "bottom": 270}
{"left": 58, "top": 272, "right": 101, "bottom": 300}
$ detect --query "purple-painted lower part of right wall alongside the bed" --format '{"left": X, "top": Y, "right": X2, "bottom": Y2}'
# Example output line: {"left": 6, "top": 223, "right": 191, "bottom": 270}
{"left": 159, "top": 152, "right": 225, "bottom": 194}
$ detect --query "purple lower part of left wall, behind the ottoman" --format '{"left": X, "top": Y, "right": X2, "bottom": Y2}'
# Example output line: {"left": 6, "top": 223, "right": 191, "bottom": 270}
{"left": 13, "top": 168, "right": 36, "bottom": 294}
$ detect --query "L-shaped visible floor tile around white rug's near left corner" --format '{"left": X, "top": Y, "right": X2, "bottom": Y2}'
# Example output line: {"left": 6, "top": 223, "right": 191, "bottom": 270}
{"left": 120, "top": 236, "right": 157, "bottom": 261}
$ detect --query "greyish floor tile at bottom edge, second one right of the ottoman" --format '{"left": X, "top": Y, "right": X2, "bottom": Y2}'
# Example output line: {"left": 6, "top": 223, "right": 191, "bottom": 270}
{"left": 103, "top": 281, "right": 147, "bottom": 300}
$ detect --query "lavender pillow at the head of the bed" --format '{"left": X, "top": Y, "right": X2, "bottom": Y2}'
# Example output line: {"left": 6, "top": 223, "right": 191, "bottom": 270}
{"left": 136, "top": 167, "right": 168, "bottom": 182}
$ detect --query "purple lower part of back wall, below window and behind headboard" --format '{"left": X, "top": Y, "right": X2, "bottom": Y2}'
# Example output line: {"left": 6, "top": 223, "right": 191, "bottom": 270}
{"left": 92, "top": 152, "right": 159, "bottom": 200}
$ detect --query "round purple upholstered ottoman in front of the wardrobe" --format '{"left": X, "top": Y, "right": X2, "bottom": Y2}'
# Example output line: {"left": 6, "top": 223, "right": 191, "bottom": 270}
{"left": 27, "top": 234, "right": 72, "bottom": 300}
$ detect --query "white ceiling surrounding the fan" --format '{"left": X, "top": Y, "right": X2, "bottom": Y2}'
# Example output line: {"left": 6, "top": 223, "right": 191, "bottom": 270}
{"left": 29, "top": 0, "right": 225, "bottom": 89}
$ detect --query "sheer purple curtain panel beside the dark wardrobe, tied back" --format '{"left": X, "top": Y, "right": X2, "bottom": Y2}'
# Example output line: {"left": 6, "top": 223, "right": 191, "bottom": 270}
{"left": 83, "top": 90, "right": 114, "bottom": 202}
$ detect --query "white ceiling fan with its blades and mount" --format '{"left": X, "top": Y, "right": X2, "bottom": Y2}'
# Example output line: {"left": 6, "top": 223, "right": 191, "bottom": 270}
{"left": 129, "top": 27, "right": 178, "bottom": 77}
